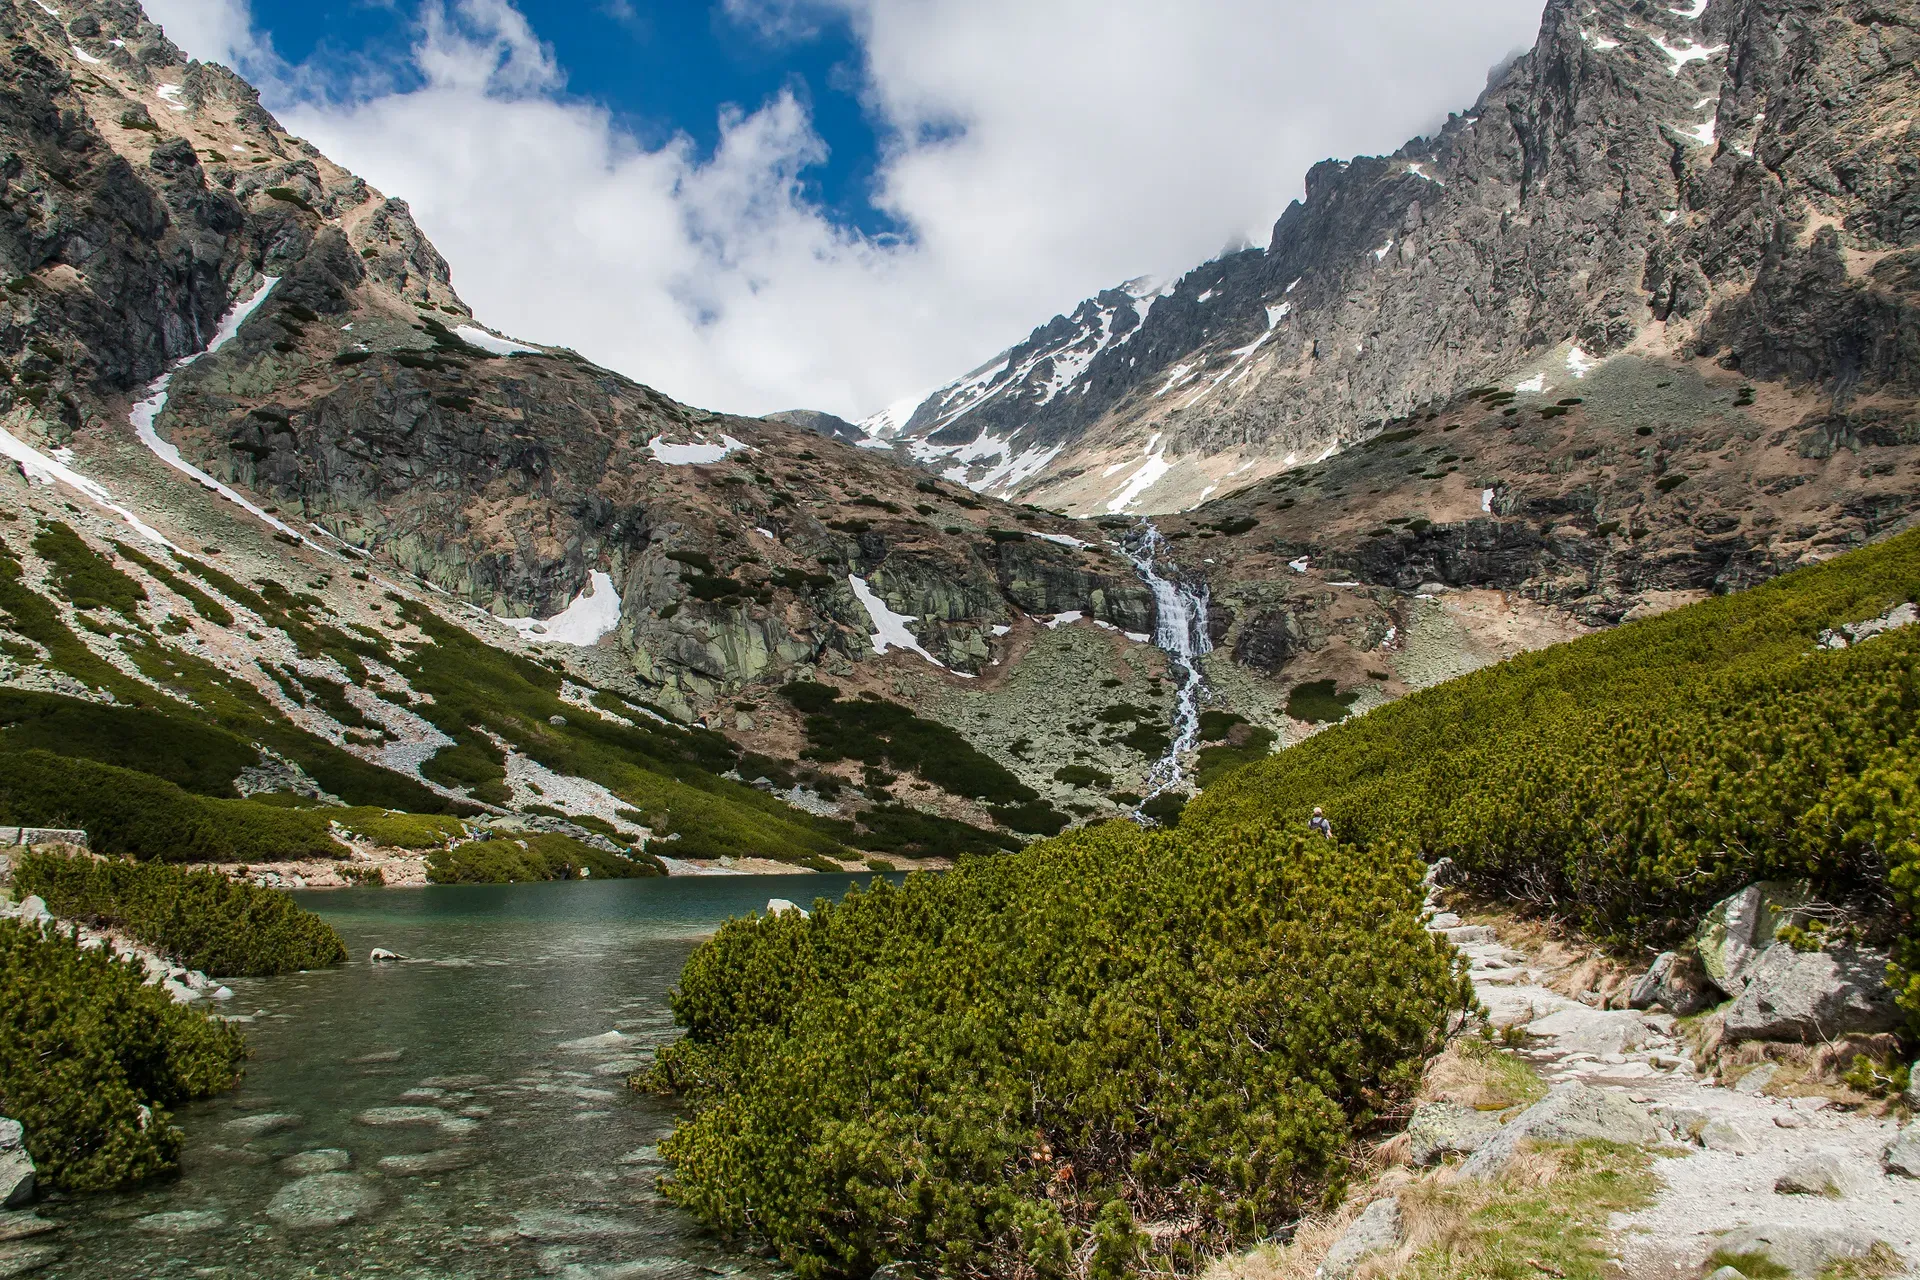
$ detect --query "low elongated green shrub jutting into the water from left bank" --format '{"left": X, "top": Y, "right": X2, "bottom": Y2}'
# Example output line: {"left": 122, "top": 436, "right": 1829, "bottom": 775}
{"left": 13, "top": 852, "right": 348, "bottom": 977}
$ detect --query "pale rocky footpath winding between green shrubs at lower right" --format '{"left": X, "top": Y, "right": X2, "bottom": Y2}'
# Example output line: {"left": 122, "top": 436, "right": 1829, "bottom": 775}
{"left": 1428, "top": 902, "right": 1920, "bottom": 1280}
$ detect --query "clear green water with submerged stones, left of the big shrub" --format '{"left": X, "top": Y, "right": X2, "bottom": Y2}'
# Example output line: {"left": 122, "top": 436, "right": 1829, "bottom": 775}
{"left": 33, "top": 875, "right": 883, "bottom": 1280}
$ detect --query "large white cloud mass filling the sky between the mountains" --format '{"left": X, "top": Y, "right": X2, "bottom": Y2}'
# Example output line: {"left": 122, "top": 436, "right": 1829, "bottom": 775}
{"left": 148, "top": 0, "right": 1540, "bottom": 416}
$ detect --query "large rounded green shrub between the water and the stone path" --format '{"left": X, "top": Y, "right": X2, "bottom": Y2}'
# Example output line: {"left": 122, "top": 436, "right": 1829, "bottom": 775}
{"left": 651, "top": 823, "right": 1471, "bottom": 1280}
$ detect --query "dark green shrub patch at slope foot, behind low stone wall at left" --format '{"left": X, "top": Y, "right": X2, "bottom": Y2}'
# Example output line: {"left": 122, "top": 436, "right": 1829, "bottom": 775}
{"left": 0, "top": 750, "right": 346, "bottom": 862}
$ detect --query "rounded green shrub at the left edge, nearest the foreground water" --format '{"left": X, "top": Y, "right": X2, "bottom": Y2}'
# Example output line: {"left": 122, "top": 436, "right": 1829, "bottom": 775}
{"left": 0, "top": 921, "right": 246, "bottom": 1192}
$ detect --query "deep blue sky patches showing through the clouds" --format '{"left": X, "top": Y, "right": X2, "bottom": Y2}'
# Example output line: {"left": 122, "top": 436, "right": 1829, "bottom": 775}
{"left": 240, "top": 0, "right": 906, "bottom": 234}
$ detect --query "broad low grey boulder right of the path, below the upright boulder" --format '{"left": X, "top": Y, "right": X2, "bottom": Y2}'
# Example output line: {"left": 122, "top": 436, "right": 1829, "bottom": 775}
{"left": 1726, "top": 942, "right": 1907, "bottom": 1042}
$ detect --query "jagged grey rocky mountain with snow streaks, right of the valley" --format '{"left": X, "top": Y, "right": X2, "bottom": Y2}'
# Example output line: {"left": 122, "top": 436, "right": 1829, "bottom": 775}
{"left": 862, "top": 0, "right": 1920, "bottom": 530}
